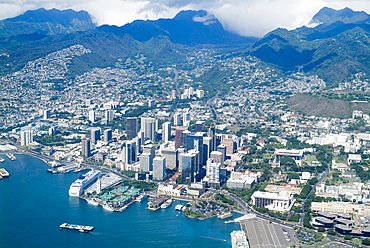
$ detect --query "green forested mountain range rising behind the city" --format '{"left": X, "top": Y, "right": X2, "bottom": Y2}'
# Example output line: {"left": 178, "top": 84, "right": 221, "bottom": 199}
{"left": 0, "top": 8, "right": 370, "bottom": 87}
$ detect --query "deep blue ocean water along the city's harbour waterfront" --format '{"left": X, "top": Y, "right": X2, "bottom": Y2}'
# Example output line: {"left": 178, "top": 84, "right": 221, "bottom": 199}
{"left": 0, "top": 155, "right": 240, "bottom": 248}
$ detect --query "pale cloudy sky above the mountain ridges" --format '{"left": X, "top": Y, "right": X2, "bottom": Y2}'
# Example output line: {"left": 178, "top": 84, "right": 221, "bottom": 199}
{"left": 0, "top": 0, "right": 370, "bottom": 37}
